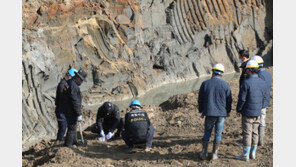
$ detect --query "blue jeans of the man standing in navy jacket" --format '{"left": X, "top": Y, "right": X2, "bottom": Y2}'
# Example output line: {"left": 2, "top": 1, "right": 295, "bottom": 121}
{"left": 202, "top": 117, "right": 225, "bottom": 142}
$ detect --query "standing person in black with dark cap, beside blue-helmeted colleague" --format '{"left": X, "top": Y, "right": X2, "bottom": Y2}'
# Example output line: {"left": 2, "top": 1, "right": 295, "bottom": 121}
{"left": 65, "top": 70, "right": 87, "bottom": 147}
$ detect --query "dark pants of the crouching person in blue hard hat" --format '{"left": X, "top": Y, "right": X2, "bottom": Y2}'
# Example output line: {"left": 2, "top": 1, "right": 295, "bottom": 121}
{"left": 122, "top": 125, "right": 154, "bottom": 148}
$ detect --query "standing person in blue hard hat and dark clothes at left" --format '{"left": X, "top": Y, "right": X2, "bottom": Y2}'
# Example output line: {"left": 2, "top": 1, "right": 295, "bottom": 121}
{"left": 55, "top": 68, "right": 78, "bottom": 142}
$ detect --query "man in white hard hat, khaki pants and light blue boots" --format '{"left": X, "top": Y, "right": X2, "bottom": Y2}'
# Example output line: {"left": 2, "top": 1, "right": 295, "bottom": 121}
{"left": 235, "top": 60, "right": 267, "bottom": 161}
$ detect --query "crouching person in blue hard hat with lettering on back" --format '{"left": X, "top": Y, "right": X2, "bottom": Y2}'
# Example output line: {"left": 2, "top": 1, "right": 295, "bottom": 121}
{"left": 122, "top": 100, "right": 154, "bottom": 153}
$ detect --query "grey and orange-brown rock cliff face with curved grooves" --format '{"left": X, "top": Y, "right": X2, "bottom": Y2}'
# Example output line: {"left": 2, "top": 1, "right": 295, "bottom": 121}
{"left": 22, "top": 0, "right": 272, "bottom": 150}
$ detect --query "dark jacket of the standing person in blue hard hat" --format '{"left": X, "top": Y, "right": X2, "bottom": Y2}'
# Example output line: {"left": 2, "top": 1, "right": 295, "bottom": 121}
{"left": 55, "top": 79, "right": 69, "bottom": 121}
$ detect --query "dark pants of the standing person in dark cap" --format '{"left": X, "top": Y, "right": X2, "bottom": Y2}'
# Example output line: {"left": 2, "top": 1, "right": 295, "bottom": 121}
{"left": 65, "top": 118, "right": 77, "bottom": 147}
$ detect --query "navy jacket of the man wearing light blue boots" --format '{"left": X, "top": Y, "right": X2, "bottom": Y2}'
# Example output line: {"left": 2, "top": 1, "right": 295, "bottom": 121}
{"left": 236, "top": 74, "right": 267, "bottom": 116}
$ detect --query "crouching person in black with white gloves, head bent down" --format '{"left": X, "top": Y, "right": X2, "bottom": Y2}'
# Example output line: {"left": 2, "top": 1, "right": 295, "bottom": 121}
{"left": 91, "top": 102, "right": 123, "bottom": 142}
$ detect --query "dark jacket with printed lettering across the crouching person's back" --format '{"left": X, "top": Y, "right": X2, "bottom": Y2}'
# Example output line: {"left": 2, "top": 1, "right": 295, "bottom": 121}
{"left": 124, "top": 109, "right": 150, "bottom": 140}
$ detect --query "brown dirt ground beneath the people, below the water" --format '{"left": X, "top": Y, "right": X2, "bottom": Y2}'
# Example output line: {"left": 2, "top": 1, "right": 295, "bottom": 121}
{"left": 22, "top": 67, "right": 273, "bottom": 167}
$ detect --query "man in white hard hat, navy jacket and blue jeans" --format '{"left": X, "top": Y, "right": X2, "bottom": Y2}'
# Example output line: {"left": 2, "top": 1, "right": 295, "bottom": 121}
{"left": 198, "top": 64, "right": 232, "bottom": 160}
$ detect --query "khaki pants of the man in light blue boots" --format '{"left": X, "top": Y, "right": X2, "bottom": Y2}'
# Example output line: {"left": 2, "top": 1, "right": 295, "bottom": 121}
{"left": 242, "top": 116, "right": 260, "bottom": 147}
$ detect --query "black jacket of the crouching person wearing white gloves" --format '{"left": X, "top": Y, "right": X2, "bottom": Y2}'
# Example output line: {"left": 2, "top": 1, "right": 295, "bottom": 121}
{"left": 96, "top": 104, "right": 120, "bottom": 132}
